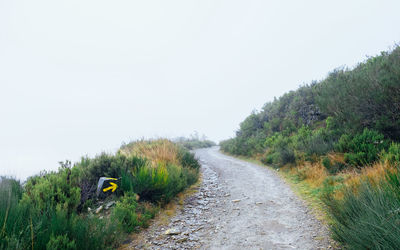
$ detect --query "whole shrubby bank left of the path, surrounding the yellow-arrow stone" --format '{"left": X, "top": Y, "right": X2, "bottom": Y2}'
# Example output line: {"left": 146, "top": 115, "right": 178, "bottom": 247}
{"left": 0, "top": 139, "right": 200, "bottom": 249}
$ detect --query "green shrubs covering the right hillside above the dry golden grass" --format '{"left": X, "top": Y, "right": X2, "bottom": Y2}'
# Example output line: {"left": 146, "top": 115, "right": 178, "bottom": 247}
{"left": 220, "top": 46, "right": 400, "bottom": 170}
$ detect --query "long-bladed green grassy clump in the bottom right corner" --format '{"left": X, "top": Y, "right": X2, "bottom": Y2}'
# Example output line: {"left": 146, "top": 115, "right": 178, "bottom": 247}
{"left": 324, "top": 172, "right": 400, "bottom": 249}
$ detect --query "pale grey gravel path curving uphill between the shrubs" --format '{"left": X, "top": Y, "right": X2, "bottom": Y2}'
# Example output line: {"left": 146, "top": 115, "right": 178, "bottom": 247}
{"left": 125, "top": 148, "right": 330, "bottom": 249}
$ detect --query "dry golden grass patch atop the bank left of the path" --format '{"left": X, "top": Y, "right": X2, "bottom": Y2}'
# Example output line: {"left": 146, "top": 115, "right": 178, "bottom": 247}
{"left": 120, "top": 139, "right": 179, "bottom": 166}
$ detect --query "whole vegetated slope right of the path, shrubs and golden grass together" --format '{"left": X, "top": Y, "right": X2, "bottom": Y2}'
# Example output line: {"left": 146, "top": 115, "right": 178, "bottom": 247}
{"left": 220, "top": 46, "right": 400, "bottom": 249}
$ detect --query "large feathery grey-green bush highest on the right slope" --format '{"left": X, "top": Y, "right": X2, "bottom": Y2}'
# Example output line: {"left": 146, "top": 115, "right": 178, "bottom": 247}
{"left": 315, "top": 46, "right": 400, "bottom": 140}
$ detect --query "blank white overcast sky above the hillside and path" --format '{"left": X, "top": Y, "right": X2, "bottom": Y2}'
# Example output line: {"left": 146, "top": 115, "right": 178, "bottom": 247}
{"left": 0, "top": 0, "right": 400, "bottom": 178}
